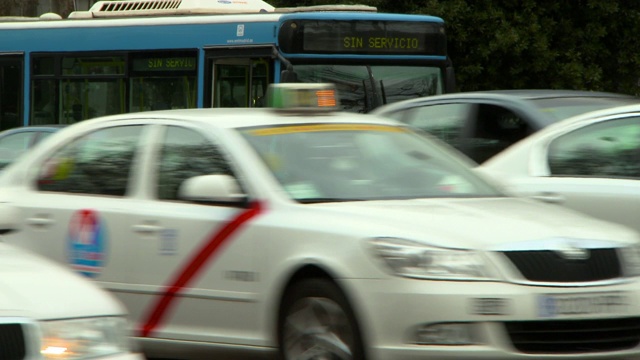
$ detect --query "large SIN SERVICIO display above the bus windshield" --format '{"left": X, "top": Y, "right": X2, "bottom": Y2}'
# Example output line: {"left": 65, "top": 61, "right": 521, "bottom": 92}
{"left": 278, "top": 20, "right": 446, "bottom": 56}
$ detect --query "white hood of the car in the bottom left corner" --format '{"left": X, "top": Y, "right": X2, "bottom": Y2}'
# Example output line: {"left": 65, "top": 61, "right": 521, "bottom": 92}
{"left": 0, "top": 243, "right": 125, "bottom": 320}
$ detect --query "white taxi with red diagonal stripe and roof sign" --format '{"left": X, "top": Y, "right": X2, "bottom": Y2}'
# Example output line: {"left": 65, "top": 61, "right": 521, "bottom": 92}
{"left": 0, "top": 85, "right": 640, "bottom": 360}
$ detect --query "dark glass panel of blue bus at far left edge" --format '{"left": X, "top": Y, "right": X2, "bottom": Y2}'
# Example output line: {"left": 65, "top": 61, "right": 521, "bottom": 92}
{"left": 0, "top": 54, "right": 24, "bottom": 130}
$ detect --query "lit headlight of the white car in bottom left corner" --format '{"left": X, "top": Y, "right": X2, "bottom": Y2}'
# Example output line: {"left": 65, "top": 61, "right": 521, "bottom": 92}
{"left": 40, "top": 317, "right": 129, "bottom": 360}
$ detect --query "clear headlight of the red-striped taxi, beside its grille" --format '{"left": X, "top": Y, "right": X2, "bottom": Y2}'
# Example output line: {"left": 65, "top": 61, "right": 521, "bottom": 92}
{"left": 370, "top": 238, "right": 493, "bottom": 280}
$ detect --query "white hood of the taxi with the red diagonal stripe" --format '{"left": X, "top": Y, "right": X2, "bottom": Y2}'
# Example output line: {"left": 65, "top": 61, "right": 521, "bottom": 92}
{"left": 308, "top": 197, "right": 638, "bottom": 249}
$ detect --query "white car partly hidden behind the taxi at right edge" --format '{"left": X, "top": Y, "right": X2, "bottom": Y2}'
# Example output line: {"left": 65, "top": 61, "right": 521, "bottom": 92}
{"left": 478, "top": 105, "right": 640, "bottom": 232}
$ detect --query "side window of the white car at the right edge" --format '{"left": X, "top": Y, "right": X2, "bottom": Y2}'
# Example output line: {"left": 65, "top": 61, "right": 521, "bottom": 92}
{"left": 548, "top": 117, "right": 640, "bottom": 178}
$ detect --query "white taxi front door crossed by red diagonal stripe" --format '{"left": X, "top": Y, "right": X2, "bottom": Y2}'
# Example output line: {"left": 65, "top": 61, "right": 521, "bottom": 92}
{"left": 121, "top": 123, "right": 264, "bottom": 345}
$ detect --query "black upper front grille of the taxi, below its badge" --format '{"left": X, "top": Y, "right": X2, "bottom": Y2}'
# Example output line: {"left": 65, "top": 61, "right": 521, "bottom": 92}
{"left": 503, "top": 249, "right": 622, "bottom": 283}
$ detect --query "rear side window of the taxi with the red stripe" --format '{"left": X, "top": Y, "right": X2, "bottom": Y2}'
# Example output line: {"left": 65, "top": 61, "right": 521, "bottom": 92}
{"left": 37, "top": 126, "right": 143, "bottom": 196}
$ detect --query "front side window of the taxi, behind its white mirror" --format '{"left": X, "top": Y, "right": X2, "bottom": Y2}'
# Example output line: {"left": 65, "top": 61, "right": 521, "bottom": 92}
{"left": 157, "top": 126, "right": 233, "bottom": 200}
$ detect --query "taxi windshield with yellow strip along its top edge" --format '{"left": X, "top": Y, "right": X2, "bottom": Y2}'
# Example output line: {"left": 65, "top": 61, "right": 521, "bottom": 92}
{"left": 241, "top": 123, "right": 501, "bottom": 203}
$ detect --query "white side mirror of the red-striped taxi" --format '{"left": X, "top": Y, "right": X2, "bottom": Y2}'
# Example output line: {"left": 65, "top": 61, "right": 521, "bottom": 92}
{"left": 178, "top": 175, "right": 247, "bottom": 205}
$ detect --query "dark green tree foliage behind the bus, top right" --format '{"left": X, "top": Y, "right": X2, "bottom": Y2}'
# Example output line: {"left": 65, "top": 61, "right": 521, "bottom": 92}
{"left": 271, "top": 0, "right": 640, "bottom": 95}
